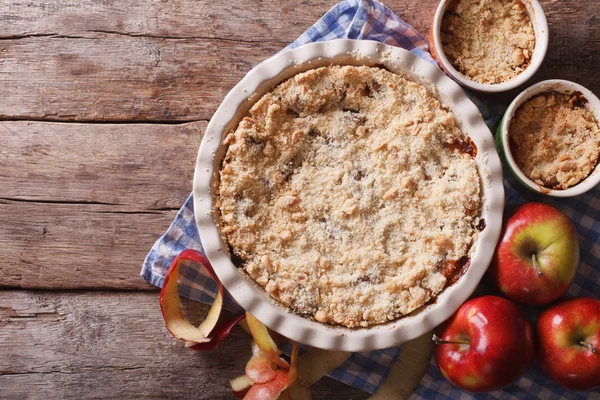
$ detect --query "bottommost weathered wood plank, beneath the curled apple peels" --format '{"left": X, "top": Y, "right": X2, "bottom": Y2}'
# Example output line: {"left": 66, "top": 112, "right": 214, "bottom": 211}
{"left": 0, "top": 291, "right": 367, "bottom": 400}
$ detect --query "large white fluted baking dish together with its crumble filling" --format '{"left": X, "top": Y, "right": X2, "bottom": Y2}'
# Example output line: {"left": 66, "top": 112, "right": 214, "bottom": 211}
{"left": 194, "top": 39, "right": 504, "bottom": 351}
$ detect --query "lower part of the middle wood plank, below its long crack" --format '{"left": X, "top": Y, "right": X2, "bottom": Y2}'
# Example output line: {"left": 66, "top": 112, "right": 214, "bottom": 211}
{"left": 0, "top": 200, "right": 176, "bottom": 290}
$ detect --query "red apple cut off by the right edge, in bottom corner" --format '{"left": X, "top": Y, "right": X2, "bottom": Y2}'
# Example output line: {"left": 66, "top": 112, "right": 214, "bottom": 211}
{"left": 537, "top": 297, "right": 600, "bottom": 390}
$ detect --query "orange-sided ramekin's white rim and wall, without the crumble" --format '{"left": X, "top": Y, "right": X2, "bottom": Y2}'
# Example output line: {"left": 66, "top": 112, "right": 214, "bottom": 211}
{"left": 429, "top": 0, "right": 548, "bottom": 93}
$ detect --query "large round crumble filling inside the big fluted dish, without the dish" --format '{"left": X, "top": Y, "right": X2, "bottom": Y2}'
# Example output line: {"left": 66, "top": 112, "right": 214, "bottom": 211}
{"left": 215, "top": 66, "right": 481, "bottom": 327}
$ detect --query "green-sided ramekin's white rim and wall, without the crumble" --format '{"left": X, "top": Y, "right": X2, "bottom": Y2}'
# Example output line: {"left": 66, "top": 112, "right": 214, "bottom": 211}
{"left": 496, "top": 79, "right": 600, "bottom": 197}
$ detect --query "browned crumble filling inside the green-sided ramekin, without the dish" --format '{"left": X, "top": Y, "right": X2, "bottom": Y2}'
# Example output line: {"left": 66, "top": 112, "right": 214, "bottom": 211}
{"left": 508, "top": 92, "right": 600, "bottom": 189}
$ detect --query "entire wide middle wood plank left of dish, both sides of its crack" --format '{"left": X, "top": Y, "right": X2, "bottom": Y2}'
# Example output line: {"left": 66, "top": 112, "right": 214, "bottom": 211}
{"left": 0, "top": 121, "right": 206, "bottom": 290}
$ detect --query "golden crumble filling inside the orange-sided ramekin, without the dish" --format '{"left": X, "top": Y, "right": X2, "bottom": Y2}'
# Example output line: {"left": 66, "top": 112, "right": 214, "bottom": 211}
{"left": 441, "top": 0, "right": 535, "bottom": 84}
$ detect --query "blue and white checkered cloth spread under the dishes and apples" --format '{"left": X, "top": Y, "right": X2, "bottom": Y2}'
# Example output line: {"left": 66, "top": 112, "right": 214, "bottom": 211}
{"left": 141, "top": 0, "right": 600, "bottom": 400}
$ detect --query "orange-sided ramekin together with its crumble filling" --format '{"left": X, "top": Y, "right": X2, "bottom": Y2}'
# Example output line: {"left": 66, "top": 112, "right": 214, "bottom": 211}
{"left": 429, "top": 0, "right": 548, "bottom": 92}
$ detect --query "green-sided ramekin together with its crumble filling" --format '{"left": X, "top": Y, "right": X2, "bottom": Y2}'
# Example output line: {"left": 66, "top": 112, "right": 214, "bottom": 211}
{"left": 496, "top": 79, "right": 600, "bottom": 197}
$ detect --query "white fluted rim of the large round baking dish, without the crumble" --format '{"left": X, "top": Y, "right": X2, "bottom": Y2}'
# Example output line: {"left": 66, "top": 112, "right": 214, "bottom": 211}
{"left": 194, "top": 39, "right": 504, "bottom": 351}
